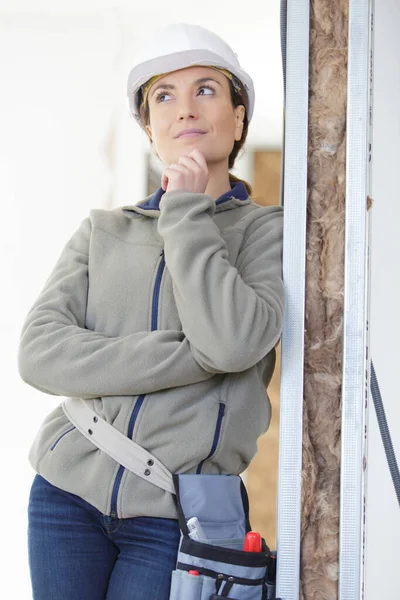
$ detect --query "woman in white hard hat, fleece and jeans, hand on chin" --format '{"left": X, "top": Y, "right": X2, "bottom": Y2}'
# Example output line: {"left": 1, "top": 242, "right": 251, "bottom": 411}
{"left": 18, "top": 24, "right": 283, "bottom": 600}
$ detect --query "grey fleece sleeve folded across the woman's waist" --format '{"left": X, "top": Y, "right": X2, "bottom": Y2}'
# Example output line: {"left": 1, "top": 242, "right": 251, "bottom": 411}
{"left": 18, "top": 217, "right": 212, "bottom": 398}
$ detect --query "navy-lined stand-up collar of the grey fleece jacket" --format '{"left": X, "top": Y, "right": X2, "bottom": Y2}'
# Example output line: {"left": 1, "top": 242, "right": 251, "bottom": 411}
{"left": 121, "top": 181, "right": 251, "bottom": 217}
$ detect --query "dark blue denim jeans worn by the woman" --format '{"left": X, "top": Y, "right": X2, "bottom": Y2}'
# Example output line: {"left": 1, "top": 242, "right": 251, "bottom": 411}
{"left": 28, "top": 474, "right": 180, "bottom": 600}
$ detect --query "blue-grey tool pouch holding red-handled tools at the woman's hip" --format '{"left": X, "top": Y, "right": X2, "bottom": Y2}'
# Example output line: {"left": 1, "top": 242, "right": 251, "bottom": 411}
{"left": 170, "top": 474, "right": 275, "bottom": 600}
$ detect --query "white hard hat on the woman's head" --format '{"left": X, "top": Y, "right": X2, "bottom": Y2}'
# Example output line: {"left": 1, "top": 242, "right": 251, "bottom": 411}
{"left": 127, "top": 23, "right": 255, "bottom": 123}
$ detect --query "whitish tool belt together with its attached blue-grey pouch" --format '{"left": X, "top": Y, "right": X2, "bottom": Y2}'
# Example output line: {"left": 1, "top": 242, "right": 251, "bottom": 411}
{"left": 62, "top": 398, "right": 276, "bottom": 600}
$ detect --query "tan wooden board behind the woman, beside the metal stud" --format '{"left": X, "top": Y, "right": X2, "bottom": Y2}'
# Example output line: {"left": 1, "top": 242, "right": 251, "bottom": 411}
{"left": 246, "top": 151, "right": 281, "bottom": 549}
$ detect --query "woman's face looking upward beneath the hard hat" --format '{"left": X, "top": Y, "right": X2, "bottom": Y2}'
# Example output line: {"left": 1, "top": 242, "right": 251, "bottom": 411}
{"left": 146, "top": 66, "right": 245, "bottom": 168}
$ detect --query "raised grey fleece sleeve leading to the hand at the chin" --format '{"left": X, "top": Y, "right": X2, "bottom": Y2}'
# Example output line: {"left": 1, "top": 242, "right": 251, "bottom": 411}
{"left": 158, "top": 192, "right": 283, "bottom": 373}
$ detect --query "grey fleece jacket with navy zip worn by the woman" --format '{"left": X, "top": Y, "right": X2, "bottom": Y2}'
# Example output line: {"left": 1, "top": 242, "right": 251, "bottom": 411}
{"left": 18, "top": 182, "right": 283, "bottom": 518}
